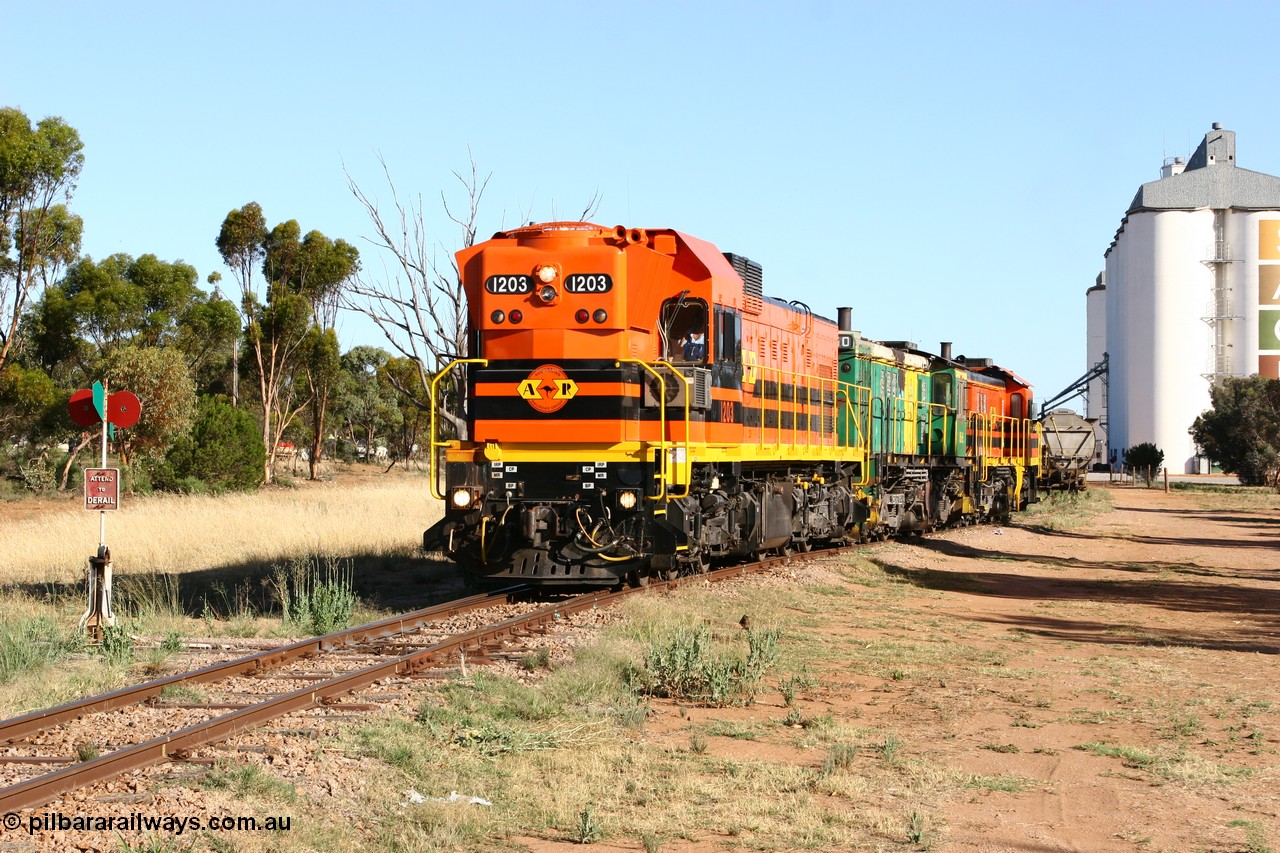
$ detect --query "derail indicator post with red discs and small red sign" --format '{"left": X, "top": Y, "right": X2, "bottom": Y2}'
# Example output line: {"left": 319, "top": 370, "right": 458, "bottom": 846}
{"left": 68, "top": 382, "right": 141, "bottom": 643}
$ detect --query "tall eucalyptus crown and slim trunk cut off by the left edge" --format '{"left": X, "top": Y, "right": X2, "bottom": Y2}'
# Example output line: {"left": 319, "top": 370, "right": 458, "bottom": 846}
{"left": 0, "top": 106, "right": 84, "bottom": 368}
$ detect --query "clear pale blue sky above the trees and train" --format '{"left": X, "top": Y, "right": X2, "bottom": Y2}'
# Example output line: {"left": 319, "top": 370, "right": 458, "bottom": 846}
{"left": 10, "top": 0, "right": 1280, "bottom": 407}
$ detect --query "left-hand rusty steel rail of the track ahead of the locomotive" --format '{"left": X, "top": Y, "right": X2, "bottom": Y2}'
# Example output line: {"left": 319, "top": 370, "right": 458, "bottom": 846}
{"left": 0, "top": 587, "right": 527, "bottom": 744}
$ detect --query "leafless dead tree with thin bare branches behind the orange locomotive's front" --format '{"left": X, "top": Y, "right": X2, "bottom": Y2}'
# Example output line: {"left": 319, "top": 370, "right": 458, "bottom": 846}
{"left": 343, "top": 158, "right": 492, "bottom": 438}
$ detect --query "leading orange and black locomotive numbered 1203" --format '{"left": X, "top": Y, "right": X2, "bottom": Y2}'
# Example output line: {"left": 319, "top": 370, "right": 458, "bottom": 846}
{"left": 424, "top": 223, "right": 865, "bottom": 583}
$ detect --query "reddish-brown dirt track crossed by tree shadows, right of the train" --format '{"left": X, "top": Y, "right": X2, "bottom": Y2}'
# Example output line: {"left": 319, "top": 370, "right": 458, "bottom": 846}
{"left": 829, "top": 489, "right": 1280, "bottom": 853}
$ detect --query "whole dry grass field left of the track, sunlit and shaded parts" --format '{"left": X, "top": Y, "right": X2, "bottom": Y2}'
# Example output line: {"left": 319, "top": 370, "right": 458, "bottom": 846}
{"left": 0, "top": 471, "right": 448, "bottom": 716}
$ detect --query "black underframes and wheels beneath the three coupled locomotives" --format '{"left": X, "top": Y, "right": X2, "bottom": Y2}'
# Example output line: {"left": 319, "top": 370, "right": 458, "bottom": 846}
{"left": 424, "top": 457, "right": 1015, "bottom": 585}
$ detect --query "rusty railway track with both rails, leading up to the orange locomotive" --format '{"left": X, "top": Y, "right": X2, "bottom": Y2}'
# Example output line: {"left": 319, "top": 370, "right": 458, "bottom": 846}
{"left": 0, "top": 548, "right": 847, "bottom": 813}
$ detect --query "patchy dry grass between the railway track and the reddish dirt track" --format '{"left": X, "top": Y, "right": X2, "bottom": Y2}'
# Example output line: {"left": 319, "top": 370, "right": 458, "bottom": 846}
{"left": 322, "top": 573, "right": 989, "bottom": 850}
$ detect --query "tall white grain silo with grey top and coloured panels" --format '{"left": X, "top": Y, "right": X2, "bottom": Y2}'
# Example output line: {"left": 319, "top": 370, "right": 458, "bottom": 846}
{"left": 1087, "top": 124, "right": 1280, "bottom": 473}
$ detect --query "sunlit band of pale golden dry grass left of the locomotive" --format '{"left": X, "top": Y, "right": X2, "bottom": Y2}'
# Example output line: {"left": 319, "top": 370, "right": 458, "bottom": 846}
{"left": 0, "top": 475, "right": 440, "bottom": 584}
